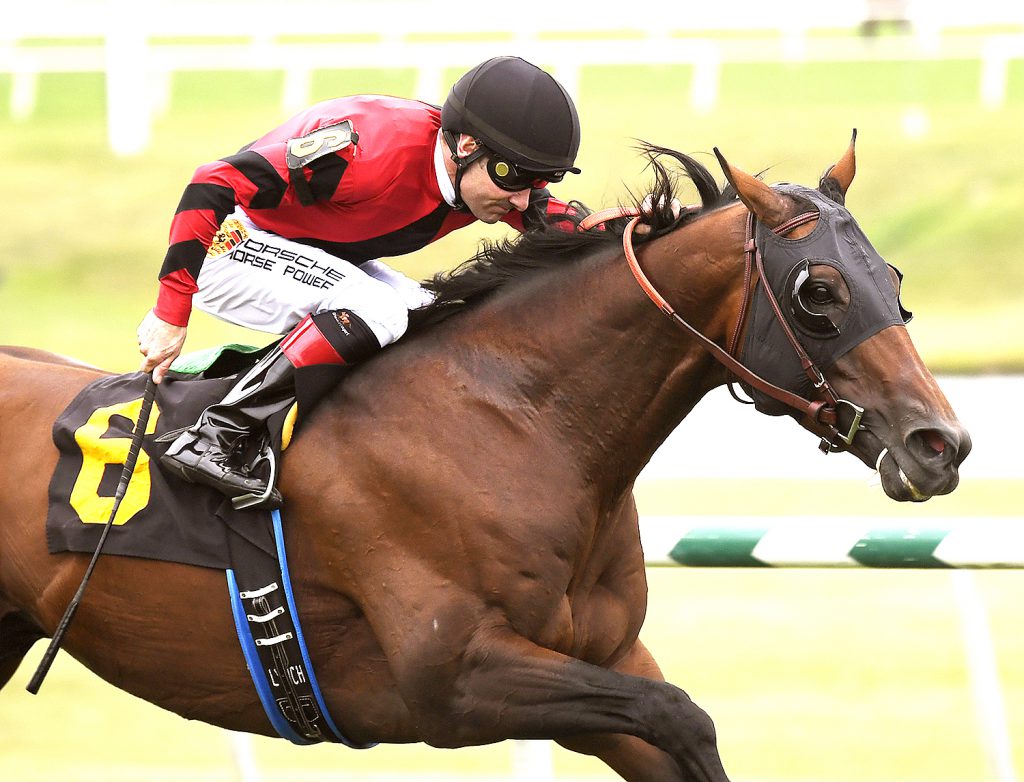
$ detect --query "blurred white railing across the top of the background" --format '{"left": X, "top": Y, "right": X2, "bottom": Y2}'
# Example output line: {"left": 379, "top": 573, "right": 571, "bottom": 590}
{"left": 0, "top": 0, "right": 1024, "bottom": 155}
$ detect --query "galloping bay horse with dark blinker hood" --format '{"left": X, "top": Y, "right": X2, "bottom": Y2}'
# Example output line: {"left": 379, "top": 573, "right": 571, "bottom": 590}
{"left": 0, "top": 137, "right": 971, "bottom": 782}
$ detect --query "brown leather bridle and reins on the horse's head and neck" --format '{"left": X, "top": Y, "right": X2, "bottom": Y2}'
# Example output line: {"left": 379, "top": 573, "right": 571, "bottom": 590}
{"left": 580, "top": 207, "right": 864, "bottom": 453}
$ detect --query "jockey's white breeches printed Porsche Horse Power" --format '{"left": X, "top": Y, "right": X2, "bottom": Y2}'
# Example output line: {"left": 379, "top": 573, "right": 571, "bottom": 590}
{"left": 193, "top": 209, "right": 432, "bottom": 347}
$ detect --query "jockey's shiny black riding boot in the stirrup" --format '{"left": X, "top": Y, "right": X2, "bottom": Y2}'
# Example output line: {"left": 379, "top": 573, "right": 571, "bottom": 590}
{"left": 160, "top": 346, "right": 295, "bottom": 508}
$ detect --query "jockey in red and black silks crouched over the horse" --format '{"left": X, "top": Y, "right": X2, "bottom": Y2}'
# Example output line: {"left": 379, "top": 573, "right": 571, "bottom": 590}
{"left": 138, "top": 57, "right": 580, "bottom": 508}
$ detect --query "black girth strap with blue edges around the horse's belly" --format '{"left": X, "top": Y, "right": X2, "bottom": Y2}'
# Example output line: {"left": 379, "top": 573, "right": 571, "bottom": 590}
{"left": 225, "top": 511, "right": 376, "bottom": 749}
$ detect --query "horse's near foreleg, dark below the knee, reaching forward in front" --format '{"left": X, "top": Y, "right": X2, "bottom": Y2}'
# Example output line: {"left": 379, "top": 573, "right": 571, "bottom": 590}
{"left": 392, "top": 626, "right": 728, "bottom": 782}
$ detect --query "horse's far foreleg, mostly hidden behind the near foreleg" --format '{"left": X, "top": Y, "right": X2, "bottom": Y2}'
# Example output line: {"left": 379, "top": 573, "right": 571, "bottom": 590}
{"left": 557, "top": 641, "right": 683, "bottom": 782}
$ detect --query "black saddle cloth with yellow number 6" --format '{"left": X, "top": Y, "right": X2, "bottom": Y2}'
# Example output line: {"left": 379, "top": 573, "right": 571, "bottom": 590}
{"left": 46, "top": 351, "right": 285, "bottom": 569}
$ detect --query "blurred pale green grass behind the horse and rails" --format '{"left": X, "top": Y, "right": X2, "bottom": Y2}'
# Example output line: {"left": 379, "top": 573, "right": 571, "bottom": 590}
{"left": 0, "top": 36, "right": 1024, "bottom": 782}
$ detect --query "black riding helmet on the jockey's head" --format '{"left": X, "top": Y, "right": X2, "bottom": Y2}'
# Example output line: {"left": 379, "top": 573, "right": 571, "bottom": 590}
{"left": 441, "top": 57, "right": 580, "bottom": 207}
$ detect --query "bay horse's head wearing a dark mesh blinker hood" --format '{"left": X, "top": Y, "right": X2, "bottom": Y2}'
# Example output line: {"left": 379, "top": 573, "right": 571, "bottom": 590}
{"left": 716, "top": 132, "right": 971, "bottom": 502}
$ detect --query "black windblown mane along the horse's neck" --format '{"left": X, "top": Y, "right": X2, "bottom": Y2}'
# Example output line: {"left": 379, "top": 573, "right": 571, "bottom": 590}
{"left": 409, "top": 141, "right": 735, "bottom": 335}
